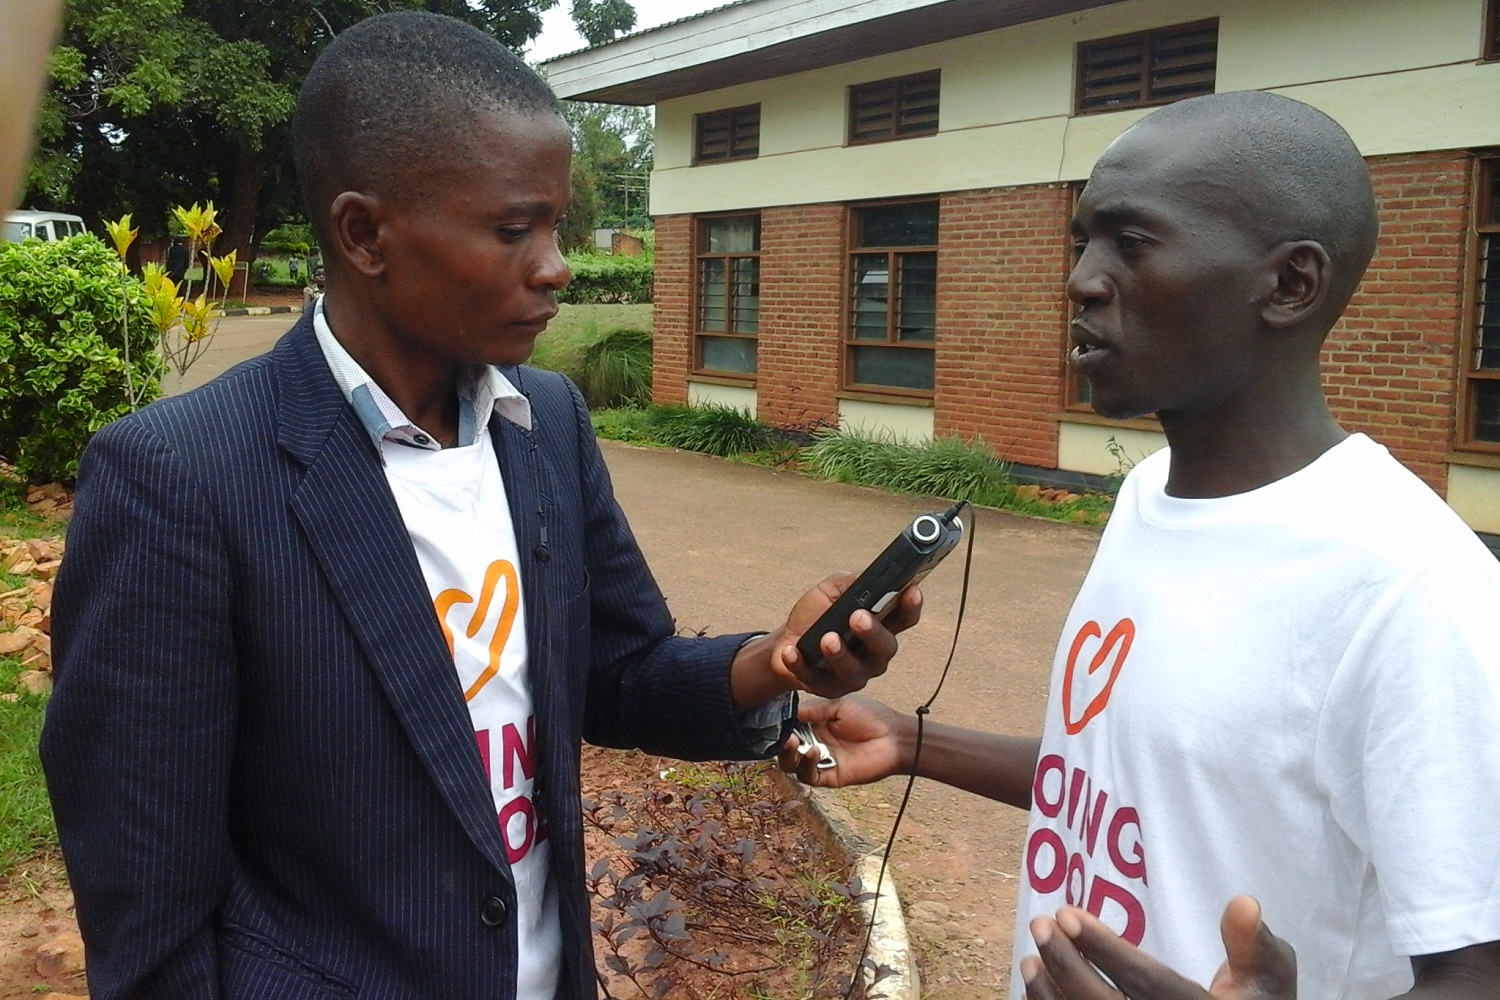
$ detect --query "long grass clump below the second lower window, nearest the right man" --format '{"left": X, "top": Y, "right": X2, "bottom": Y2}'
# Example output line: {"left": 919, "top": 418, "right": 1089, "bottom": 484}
{"left": 803, "top": 429, "right": 1016, "bottom": 507}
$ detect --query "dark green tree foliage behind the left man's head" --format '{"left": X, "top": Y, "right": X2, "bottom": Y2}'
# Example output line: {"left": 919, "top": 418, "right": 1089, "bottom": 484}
{"left": 26, "top": 0, "right": 635, "bottom": 261}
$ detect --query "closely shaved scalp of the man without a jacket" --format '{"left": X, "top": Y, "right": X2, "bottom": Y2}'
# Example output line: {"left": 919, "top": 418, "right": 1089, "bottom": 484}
{"left": 1100, "top": 90, "right": 1380, "bottom": 315}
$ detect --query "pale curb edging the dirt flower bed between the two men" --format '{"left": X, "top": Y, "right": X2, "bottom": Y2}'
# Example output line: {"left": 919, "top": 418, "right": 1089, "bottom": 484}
{"left": 773, "top": 769, "right": 921, "bottom": 1000}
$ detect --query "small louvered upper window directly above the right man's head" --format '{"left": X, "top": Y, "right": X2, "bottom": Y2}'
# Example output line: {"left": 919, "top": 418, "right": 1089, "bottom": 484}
{"left": 1074, "top": 21, "right": 1218, "bottom": 114}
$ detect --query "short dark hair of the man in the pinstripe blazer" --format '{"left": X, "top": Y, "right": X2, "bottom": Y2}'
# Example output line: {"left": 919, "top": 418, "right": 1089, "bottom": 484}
{"left": 293, "top": 10, "right": 561, "bottom": 249}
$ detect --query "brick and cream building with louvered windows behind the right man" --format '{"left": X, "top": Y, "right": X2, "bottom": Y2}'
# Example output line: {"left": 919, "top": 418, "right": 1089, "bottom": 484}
{"left": 545, "top": 0, "right": 1500, "bottom": 541}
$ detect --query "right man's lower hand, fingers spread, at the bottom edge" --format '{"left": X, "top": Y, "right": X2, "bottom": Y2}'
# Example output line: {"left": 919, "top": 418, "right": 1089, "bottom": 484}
{"left": 1022, "top": 897, "right": 1298, "bottom": 1000}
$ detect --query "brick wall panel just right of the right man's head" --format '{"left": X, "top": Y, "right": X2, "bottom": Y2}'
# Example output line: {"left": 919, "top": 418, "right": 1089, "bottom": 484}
{"left": 1323, "top": 153, "right": 1469, "bottom": 493}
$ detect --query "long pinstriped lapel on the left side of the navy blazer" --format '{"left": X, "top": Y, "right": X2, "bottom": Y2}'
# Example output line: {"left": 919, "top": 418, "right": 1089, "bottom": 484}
{"left": 276, "top": 321, "right": 509, "bottom": 871}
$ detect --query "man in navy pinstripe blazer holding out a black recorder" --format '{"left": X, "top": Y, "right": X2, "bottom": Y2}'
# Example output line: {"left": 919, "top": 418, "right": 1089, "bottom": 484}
{"left": 42, "top": 13, "right": 918, "bottom": 1000}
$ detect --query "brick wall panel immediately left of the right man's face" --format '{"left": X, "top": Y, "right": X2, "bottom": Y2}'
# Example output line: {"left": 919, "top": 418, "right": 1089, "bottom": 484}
{"left": 933, "top": 184, "right": 1073, "bottom": 468}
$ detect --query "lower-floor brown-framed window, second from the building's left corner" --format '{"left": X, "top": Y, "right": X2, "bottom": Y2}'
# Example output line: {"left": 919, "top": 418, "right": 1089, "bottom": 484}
{"left": 845, "top": 201, "right": 938, "bottom": 393}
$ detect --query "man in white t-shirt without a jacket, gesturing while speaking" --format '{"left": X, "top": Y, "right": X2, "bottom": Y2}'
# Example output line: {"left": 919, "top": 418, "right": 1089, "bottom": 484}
{"left": 786, "top": 93, "right": 1500, "bottom": 1000}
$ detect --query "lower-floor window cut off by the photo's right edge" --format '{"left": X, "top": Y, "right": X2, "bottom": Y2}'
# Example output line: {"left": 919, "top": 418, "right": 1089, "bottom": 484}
{"left": 1460, "top": 153, "right": 1500, "bottom": 451}
